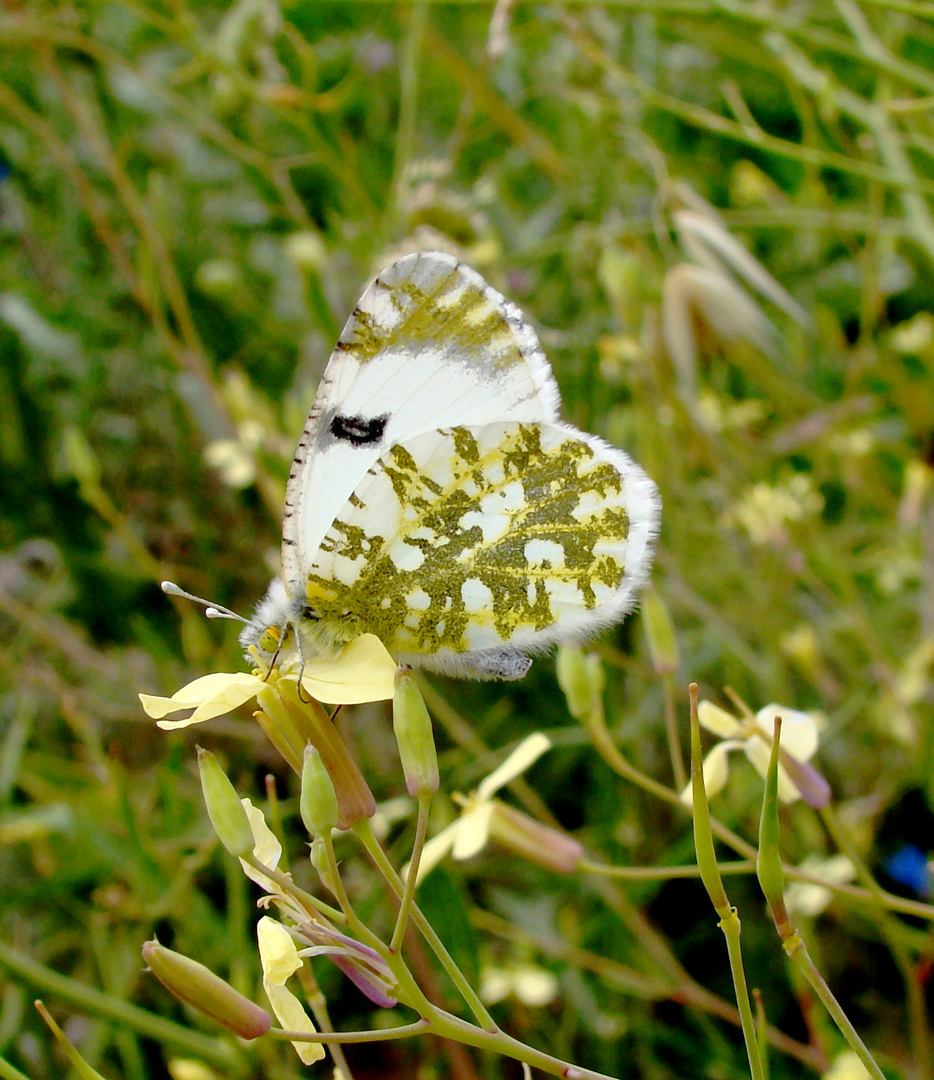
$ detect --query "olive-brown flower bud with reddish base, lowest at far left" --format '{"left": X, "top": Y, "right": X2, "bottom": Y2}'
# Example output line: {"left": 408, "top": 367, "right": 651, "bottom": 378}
{"left": 143, "top": 941, "right": 272, "bottom": 1039}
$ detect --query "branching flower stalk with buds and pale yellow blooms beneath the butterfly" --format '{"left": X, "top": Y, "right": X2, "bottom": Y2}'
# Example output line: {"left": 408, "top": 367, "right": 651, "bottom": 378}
{"left": 144, "top": 669, "right": 626, "bottom": 1080}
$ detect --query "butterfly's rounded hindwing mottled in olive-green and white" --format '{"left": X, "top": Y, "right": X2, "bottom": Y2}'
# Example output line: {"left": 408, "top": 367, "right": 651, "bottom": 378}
{"left": 307, "top": 422, "right": 656, "bottom": 673}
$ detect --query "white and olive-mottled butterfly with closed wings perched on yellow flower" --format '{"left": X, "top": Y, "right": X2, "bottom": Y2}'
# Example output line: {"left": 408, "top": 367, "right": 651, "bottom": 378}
{"left": 240, "top": 252, "right": 660, "bottom": 679}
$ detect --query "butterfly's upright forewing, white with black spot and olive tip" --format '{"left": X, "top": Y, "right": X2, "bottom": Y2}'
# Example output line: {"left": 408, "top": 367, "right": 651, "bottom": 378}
{"left": 282, "top": 252, "right": 559, "bottom": 596}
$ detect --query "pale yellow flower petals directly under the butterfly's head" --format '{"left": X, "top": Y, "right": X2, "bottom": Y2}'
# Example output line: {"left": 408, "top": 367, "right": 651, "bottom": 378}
{"left": 139, "top": 634, "right": 396, "bottom": 730}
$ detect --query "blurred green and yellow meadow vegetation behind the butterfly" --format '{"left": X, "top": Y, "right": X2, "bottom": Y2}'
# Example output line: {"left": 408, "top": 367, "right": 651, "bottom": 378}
{"left": 0, "top": 0, "right": 934, "bottom": 1080}
